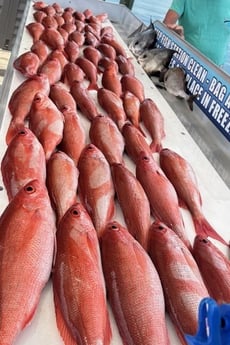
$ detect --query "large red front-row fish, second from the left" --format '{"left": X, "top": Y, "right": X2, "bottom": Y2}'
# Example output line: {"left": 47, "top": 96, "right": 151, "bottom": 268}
{"left": 53, "top": 203, "right": 111, "bottom": 345}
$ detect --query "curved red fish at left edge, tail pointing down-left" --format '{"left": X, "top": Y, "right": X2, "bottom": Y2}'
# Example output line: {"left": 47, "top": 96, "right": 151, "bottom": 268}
{"left": 6, "top": 75, "right": 50, "bottom": 144}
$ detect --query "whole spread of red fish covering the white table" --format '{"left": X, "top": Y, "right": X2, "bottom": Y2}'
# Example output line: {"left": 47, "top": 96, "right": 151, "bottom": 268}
{"left": 0, "top": 1, "right": 230, "bottom": 345}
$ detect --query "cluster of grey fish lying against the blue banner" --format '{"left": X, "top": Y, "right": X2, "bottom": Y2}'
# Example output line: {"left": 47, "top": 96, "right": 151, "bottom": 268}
{"left": 129, "top": 22, "right": 196, "bottom": 110}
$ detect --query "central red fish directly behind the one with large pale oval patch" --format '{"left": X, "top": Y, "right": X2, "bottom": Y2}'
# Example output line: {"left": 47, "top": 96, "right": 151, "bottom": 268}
{"left": 89, "top": 115, "right": 125, "bottom": 164}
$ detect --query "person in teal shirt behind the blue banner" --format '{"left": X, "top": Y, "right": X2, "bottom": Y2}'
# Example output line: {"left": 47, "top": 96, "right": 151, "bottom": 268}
{"left": 163, "top": 0, "right": 230, "bottom": 66}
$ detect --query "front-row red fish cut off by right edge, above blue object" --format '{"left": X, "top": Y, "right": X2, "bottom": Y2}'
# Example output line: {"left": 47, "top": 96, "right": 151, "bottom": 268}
{"left": 193, "top": 235, "right": 230, "bottom": 304}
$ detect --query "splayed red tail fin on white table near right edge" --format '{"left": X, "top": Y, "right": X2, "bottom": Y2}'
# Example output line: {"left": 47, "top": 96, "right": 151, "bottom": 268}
{"left": 193, "top": 217, "right": 229, "bottom": 246}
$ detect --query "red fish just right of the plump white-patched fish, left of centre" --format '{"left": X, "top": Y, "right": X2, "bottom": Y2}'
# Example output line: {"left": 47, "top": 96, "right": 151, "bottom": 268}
{"left": 59, "top": 107, "right": 86, "bottom": 166}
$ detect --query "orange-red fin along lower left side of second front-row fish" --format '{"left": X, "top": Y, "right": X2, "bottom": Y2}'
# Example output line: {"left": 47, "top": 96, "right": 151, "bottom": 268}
{"left": 54, "top": 291, "right": 76, "bottom": 345}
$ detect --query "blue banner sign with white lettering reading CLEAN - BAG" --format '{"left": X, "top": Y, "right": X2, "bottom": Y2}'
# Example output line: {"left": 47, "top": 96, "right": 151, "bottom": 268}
{"left": 154, "top": 21, "right": 230, "bottom": 141}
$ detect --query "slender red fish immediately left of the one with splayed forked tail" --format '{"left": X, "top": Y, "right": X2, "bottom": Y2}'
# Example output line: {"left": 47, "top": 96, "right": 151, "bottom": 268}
{"left": 136, "top": 152, "right": 191, "bottom": 248}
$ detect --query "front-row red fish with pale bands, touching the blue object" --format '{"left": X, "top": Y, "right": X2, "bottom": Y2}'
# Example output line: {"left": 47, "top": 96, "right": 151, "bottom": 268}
{"left": 148, "top": 222, "right": 209, "bottom": 345}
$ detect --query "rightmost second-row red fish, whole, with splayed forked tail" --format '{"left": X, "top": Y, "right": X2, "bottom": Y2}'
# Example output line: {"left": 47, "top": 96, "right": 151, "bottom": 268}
{"left": 160, "top": 149, "right": 228, "bottom": 245}
